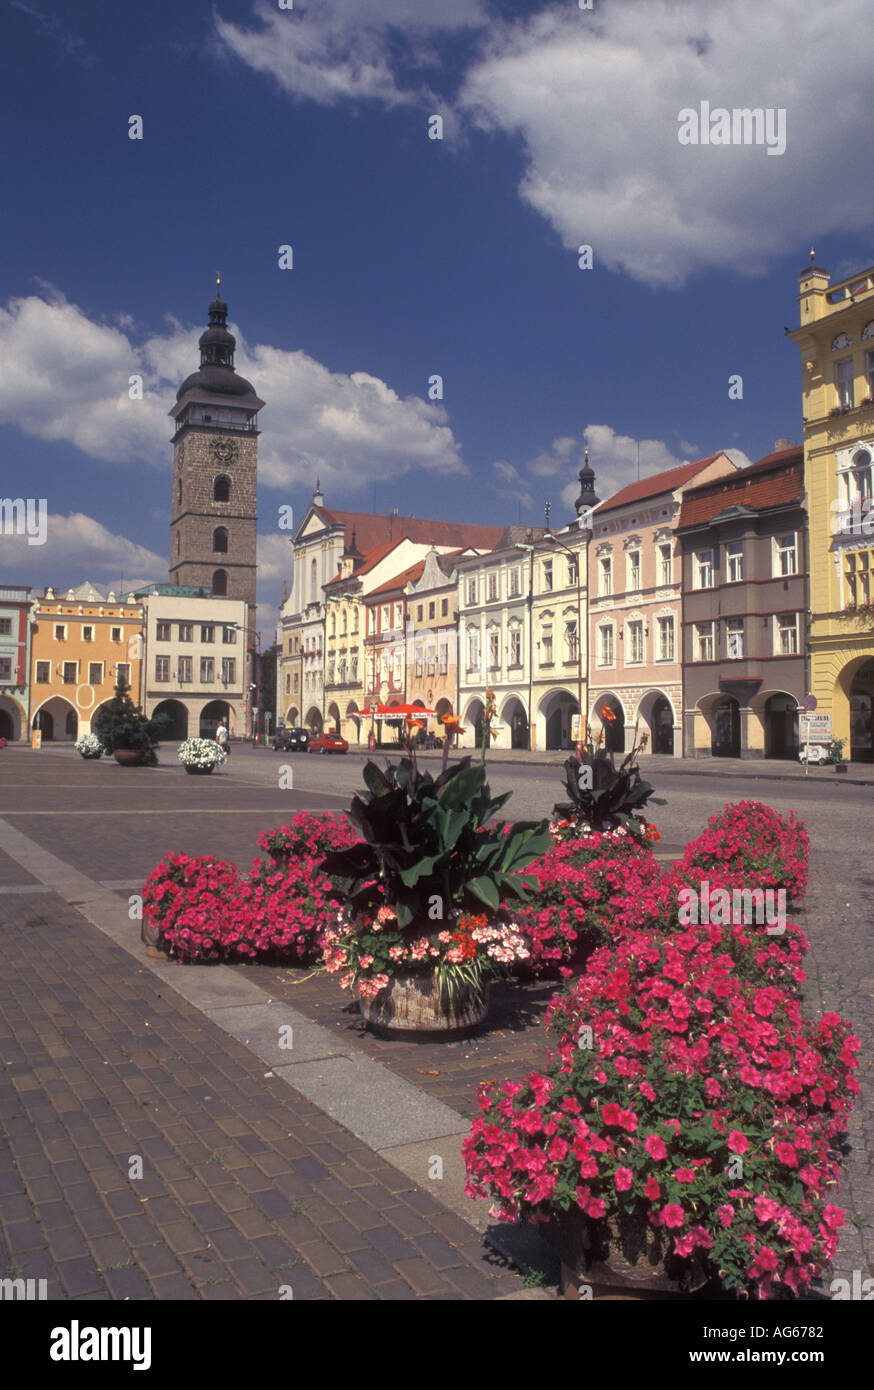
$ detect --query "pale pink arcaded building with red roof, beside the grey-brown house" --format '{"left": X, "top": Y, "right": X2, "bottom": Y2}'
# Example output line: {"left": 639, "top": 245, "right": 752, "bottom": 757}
{"left": 589, "top": 453, "right": 735, "bottom": 758}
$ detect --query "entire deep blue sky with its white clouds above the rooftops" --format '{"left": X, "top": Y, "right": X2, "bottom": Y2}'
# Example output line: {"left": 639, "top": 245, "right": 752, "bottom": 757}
{"left": 0, "top": 0, "right": 874, "bottom": 628}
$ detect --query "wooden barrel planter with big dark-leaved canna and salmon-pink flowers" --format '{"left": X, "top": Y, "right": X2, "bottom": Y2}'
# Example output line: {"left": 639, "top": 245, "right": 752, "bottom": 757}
{"left": 321, "top": 750, "right": 550, "bottom": 1033}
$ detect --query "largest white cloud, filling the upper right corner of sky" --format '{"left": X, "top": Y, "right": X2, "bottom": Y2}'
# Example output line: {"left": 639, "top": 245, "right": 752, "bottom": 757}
{"left": 461, "top": 0, "right": 874, "bottom": 286}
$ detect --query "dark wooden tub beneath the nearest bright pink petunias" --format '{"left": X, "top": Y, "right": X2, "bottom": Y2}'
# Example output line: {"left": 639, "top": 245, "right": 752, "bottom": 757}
{"left": 542, "top": 1209, "right": 718, "bottom": 1300}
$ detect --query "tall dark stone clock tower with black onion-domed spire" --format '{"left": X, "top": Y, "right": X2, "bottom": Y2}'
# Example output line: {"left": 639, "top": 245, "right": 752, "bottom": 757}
{"left": 170, "top": 279, "right": 264, "bottom": 637}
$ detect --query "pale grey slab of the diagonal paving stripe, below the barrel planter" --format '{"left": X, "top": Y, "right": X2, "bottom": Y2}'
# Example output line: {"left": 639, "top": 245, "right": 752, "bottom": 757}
{"left": 274, "top": 1056, "right": 470, "bottom": 1152}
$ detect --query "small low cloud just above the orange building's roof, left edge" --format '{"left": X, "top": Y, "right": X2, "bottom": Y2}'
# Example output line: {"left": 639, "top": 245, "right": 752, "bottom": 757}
{"left": 0, "top": 512, "right": 167, "bottom": 592}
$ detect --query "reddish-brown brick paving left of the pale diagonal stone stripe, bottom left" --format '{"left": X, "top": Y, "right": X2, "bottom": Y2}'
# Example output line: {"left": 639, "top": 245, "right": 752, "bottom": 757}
{"left": 0, "top": 894, "right": 521, "bottom": 1300}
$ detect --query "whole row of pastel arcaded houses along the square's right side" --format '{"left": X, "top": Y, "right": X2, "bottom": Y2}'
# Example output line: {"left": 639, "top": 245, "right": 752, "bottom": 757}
{"left": 277, "top": 256, "right": 874, "bottom": 760}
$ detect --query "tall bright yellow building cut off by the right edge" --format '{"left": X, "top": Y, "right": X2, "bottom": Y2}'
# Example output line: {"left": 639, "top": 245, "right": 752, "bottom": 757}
{"left": 789, "top": 252, "right": 874, "bottom": 762}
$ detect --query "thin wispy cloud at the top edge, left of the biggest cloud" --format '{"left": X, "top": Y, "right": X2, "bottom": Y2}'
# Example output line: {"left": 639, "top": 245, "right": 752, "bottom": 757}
{"left": 215, "top": 0, "right": 486, "bottom": 107}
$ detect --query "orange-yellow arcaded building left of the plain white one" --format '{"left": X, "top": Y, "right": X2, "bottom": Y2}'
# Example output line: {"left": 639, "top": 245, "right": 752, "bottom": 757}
{"left": 31, "top": 585, "right": 143, "bottom": 742}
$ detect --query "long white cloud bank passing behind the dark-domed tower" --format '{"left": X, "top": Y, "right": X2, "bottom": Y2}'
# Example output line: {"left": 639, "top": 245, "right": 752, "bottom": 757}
{"left": 0, "top": 291, "right": 465, "bottom": 493}
